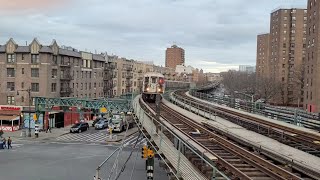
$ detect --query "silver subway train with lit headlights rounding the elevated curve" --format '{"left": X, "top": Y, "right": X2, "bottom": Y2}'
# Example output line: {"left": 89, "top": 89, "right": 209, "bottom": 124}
{"left": 142, "top": 72, "right": 190, "bottom": 102}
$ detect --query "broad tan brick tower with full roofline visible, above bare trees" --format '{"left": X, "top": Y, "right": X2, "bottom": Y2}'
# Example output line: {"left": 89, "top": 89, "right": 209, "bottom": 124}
{"left": 268, "top": 8, "right": 307, "bottom": 105}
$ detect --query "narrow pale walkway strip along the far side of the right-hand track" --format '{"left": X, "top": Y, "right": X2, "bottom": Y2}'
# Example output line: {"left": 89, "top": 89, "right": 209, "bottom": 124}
{"left": 186, "top": 92, "right": 320, "bottom": 138}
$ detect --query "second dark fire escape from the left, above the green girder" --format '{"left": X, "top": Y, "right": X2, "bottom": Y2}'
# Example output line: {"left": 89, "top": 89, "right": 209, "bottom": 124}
{"left": 103, "top": 63, "right": 115, "bottom": 97}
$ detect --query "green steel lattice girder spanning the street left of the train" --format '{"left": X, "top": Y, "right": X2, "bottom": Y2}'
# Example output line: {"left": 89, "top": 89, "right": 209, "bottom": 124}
{"left": 35, "top": 97, "right": 132, "bottom": 112}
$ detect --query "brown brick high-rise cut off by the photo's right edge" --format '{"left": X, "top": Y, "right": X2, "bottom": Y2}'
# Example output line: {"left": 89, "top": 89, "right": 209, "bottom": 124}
{"left": 304, "top": 0, "right": 320, "bottom": 112}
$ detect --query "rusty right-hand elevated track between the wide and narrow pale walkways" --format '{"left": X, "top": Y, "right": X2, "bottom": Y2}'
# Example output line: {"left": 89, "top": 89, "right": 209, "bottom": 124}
{"left": 173, "top": 91, "right": 320, "bottom": 157}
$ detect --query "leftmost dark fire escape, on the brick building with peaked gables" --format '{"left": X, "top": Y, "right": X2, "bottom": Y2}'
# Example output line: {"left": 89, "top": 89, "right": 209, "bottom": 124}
{"left": 60, "top": 59, "right": 73, "bottom": 97}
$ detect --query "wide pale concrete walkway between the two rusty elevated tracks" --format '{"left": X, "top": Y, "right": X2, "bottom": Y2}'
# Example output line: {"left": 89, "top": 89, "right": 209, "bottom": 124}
{"left": 166, "top": 93, "right": 320, "bottom": 176}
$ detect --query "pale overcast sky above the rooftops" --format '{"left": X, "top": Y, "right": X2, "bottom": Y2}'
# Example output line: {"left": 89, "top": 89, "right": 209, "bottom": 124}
{"left": 0, "top": 0, "right": 307, "bottom": 72}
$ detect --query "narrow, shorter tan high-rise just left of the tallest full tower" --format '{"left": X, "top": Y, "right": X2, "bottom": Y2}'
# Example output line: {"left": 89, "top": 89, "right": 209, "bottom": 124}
{"left": 256, "top": 33, "right": 270, "bottom": 78}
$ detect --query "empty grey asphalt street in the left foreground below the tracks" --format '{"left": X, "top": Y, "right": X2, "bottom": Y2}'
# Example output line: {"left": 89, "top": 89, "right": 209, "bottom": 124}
{"left": 0, "top": 143, "right": 168, "bottom": 180}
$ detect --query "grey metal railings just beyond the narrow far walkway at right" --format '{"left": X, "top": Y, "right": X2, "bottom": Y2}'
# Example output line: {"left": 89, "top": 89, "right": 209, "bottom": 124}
{"left": 189, "top": 89, "right": 320, "bottom": 130}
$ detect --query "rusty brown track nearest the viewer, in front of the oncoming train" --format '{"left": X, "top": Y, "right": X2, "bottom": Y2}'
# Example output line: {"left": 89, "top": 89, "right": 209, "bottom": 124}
{"left": 140, "top": 97, "right": 315, "bottom": 179}
